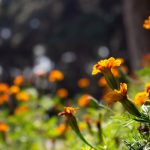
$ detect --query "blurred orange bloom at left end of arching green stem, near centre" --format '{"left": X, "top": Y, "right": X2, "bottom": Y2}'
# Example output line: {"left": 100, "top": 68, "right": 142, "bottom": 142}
{"left": 78, "top": 94, "right": 91, "bottom": 107}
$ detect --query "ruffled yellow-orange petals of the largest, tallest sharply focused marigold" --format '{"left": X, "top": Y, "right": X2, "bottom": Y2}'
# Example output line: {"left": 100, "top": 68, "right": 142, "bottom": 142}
{"left": 92, "top": 57, "right": 122, "bottom": 75}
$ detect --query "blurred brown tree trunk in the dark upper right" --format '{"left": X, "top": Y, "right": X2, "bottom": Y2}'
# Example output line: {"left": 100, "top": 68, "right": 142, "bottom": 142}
{"left": 123, "top": 0, "right": 150, "bottom": 70}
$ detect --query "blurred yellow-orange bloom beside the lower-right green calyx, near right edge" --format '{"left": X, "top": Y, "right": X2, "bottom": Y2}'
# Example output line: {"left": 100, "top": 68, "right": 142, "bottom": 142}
{"left": 133, "top": 92, "right": 149, "bottom": 106}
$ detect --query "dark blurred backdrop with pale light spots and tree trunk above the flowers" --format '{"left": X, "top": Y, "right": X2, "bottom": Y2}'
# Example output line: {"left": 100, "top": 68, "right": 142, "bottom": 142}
{"left": 0, "top": 0, "right": 150, "bottom": 95}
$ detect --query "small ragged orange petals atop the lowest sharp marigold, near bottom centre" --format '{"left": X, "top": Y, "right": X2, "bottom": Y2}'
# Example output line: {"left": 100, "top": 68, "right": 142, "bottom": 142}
{"left": 58, "top": 107, "right": 78, "bottom": 116}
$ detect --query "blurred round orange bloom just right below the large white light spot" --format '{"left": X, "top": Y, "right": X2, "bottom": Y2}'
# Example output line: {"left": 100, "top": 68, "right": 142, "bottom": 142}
{"left": 49, "top": 70, "right": 64, "bottom": 82}
